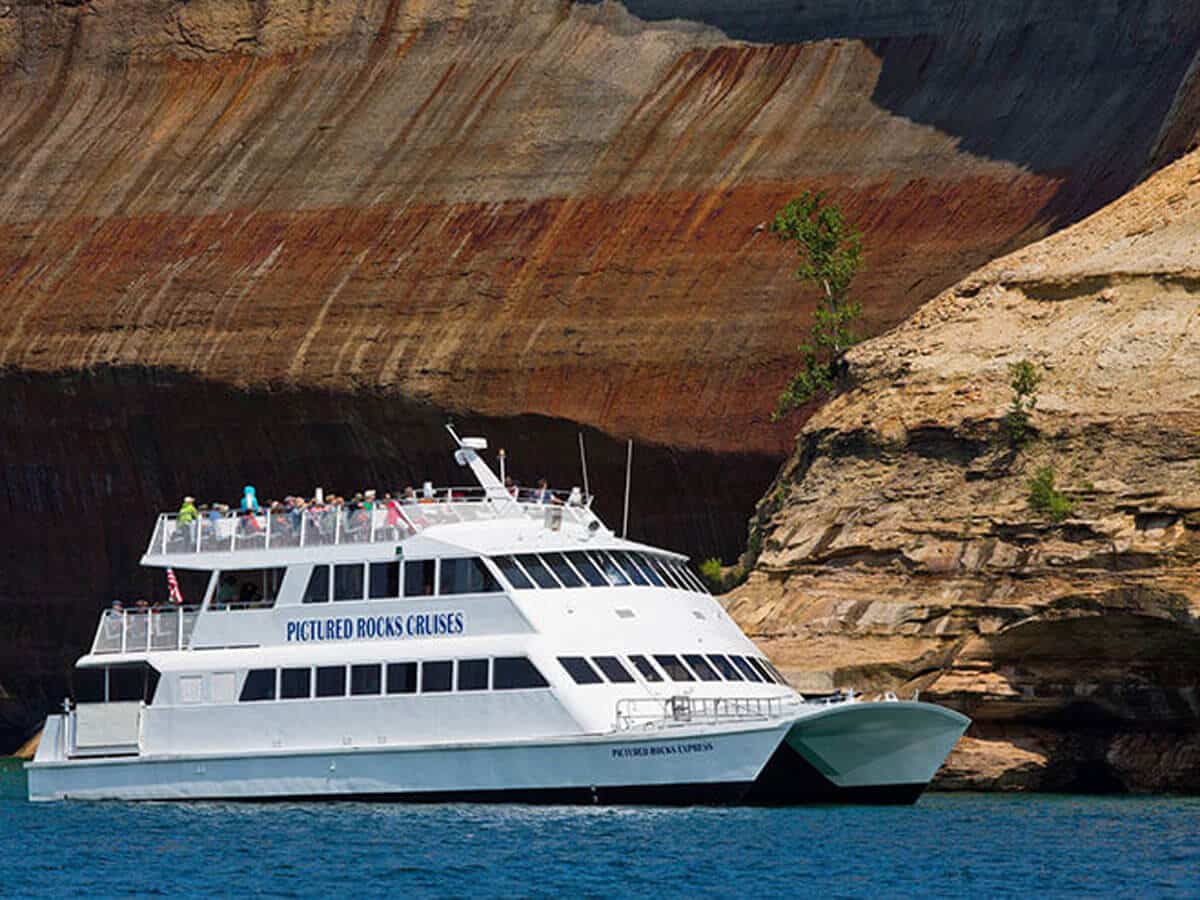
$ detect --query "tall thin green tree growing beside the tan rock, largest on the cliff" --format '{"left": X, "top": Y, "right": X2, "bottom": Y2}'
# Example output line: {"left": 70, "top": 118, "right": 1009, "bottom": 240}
{"left": 770, "top": 191, "right": 863, "bottom": 421}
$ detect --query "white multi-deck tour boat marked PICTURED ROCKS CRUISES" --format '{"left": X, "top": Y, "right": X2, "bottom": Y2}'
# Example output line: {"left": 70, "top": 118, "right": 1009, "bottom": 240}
{"left": 28, "top": 430, "right": 968, "bottom": 804}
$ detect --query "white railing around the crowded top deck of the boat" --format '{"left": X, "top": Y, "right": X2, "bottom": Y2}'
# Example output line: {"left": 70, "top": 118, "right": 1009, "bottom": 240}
{"left": 146, "top": 487, "right": 596, "bottom": 556}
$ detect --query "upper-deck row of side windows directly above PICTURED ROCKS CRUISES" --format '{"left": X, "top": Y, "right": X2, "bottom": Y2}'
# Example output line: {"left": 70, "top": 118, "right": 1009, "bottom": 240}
{"left": 304, "top": 557, "right": 500, "bottom": 604}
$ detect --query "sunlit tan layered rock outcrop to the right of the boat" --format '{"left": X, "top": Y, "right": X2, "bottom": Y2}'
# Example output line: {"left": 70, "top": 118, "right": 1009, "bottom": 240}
{"left": 732, "top": 152, "right": 1200, "bottom": 791}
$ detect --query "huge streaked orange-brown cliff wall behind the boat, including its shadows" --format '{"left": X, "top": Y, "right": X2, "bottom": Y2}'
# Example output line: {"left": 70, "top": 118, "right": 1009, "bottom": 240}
{"left": 0, "top": 0, "right": 1200, "bottom": 748}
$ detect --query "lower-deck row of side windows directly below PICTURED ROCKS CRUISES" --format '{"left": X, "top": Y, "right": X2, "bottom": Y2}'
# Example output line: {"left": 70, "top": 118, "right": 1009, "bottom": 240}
{"left": 238, "top": 656, "right": 550, "bottom": 703}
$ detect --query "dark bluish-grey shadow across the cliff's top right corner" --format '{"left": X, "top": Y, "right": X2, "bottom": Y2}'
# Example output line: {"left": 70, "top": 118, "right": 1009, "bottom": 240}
{"left": 577, "top": 0, "right": 1200, "bottom": 226}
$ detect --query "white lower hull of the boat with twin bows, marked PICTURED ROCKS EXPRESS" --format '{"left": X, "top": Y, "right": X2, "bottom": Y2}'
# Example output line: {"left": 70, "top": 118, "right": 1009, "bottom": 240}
{"left": 29, "top": 703, "right": 967, "bottom": 805}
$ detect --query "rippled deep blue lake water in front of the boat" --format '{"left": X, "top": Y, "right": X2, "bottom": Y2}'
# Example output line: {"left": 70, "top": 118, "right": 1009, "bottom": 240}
{"left": 0, "top": 761, "right": 1200, "bottom": 898}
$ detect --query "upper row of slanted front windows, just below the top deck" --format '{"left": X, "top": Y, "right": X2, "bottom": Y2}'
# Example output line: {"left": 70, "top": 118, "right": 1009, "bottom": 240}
{"left": 492, "top": 550, "right": 708, "bottom": 594}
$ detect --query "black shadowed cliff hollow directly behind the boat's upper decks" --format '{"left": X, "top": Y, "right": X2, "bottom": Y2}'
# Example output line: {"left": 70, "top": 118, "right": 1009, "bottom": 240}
{"left": 0, "top": 368, "right": 779, "bottom": 752}
